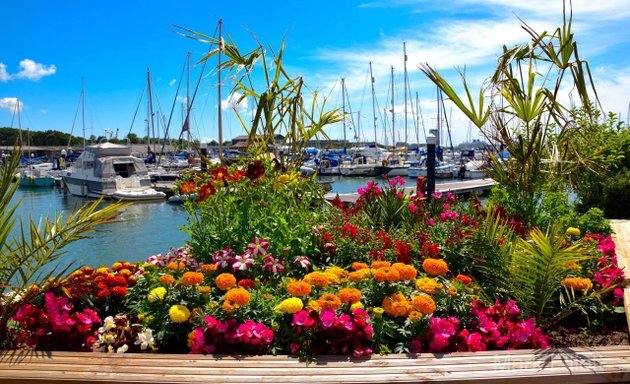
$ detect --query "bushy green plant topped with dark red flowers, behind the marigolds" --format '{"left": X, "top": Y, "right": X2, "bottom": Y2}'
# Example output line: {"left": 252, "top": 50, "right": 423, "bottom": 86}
{"left": 179, "top": 161, "right": 323, "bottom": 268}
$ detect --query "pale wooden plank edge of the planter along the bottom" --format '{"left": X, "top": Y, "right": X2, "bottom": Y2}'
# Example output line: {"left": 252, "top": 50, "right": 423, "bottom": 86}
{"left": 0, "top": 346, "right": 630, "bottom": 384}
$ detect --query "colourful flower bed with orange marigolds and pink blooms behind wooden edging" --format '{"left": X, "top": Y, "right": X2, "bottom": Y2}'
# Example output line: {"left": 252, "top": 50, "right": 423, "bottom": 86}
{"left": 3, "top": 162, "right": 624, "bottom": 360}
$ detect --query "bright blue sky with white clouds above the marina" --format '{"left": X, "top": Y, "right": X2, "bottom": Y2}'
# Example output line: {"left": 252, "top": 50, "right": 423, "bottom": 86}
{"left": 0, "top": 0, "right": 630, "bottom": 143}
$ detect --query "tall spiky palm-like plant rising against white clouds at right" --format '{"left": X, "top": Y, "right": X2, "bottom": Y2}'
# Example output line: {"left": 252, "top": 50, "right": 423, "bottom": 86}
{"left": 420, "top": 2, "right": 606, "bottom": 224}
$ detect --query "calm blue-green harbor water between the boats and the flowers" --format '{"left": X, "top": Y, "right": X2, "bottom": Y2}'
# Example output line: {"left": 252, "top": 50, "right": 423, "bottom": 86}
{"left": 14, "top": 176, "right": 444, "bottom": 267}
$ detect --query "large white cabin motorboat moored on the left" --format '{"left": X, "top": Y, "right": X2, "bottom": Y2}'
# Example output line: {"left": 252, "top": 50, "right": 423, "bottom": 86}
{"left": 61, "top": 142, "right": 166, "bottom": 201}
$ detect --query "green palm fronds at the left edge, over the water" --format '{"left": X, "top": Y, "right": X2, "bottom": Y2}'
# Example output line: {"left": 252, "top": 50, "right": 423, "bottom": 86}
{"left": 0, "top": 149, "right": 126, "bottom": 342}
